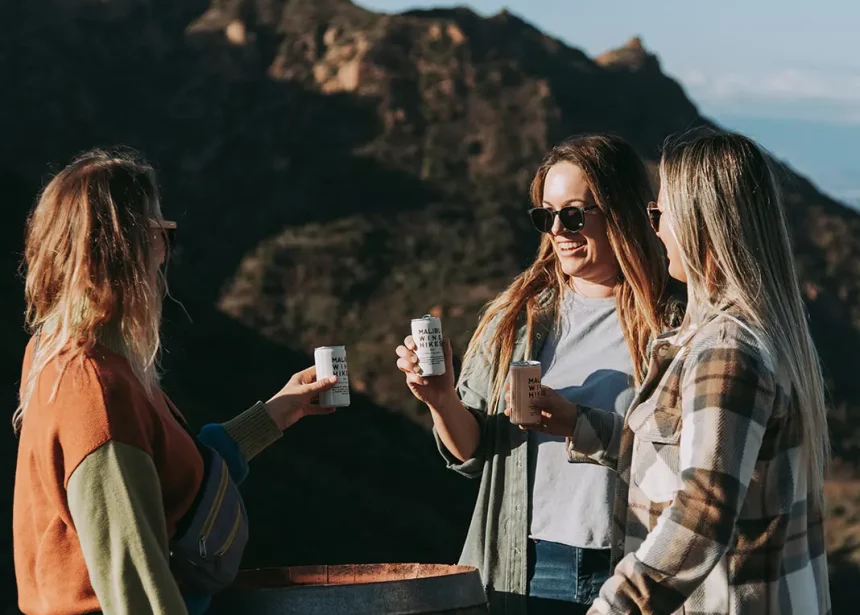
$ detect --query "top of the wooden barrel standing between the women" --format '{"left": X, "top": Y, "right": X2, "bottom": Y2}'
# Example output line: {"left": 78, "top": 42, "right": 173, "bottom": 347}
{"left": 207, "top": 564, "right": 488, "bottom": 615}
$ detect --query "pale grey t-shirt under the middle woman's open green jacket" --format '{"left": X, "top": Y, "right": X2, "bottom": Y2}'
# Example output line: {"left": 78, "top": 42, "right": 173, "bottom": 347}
{"left": 528, "top": 292, "right": 635, "bottom": 549}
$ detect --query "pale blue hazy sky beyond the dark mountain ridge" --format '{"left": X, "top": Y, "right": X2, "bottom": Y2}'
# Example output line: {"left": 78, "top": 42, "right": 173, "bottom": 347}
{"left": 357, "top": 0, "right": 860, "bottom": 205}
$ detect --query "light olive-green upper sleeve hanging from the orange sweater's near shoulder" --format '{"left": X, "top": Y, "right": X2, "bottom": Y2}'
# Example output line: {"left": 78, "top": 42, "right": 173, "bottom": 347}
{"left": 68, "top": 442, "right": 188, "bottom": 615}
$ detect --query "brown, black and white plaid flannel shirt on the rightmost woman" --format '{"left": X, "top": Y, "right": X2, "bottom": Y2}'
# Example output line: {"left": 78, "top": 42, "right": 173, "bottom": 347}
{"left": 568, "top": 312, "right": 831, "bottom": 615}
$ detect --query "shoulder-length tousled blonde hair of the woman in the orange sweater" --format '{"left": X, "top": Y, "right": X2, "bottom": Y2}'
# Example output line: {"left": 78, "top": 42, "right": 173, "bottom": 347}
{"left": 12, "top": 150, "right": 166, "bottom": 431}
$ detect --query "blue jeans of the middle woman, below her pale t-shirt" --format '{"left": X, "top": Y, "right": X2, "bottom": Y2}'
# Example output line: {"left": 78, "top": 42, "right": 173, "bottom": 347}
{"left": 528, "top": 540, "right": 610, "bottom": 615}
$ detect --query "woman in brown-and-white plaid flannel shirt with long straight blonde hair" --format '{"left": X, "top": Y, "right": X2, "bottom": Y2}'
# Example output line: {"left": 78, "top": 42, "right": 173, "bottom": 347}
{"left": 510, "top": 134, "right": 831, "bottom": 615}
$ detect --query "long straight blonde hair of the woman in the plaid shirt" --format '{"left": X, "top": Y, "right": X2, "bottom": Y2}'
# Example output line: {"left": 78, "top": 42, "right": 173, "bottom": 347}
{"left": 660, "top": 134, "right": 830, "bottom": 498}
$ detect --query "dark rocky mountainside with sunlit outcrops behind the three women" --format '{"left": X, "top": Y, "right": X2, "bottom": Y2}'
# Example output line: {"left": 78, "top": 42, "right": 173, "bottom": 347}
{"left": 0, "top": 0, "right": 860, "bottom": 608}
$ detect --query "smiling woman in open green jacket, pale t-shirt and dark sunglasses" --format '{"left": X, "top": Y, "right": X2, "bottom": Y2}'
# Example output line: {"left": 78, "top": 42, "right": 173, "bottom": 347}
{"left": 397, "top": 135, "right": 672, "bottom": 615}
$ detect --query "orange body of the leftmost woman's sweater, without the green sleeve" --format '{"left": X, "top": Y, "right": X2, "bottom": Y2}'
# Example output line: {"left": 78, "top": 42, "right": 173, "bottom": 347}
{"left": 13, "top": 341, "right": 203, "bottom": 615}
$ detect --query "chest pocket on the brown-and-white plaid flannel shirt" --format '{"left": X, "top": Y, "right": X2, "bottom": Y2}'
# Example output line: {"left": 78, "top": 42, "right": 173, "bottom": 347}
{"left": 627, "top": 400, "right": 682, "bottom": 502}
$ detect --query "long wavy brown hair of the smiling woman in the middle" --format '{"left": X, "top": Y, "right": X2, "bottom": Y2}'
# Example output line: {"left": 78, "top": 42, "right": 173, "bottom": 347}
{"left": 463, "top": 135, "right": 674, "bottom": 413}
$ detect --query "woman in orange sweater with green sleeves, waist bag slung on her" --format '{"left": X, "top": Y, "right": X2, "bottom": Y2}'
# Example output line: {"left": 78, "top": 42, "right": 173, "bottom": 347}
{"left": 13, "top": 151, "right": 335, "bottom": 615}
